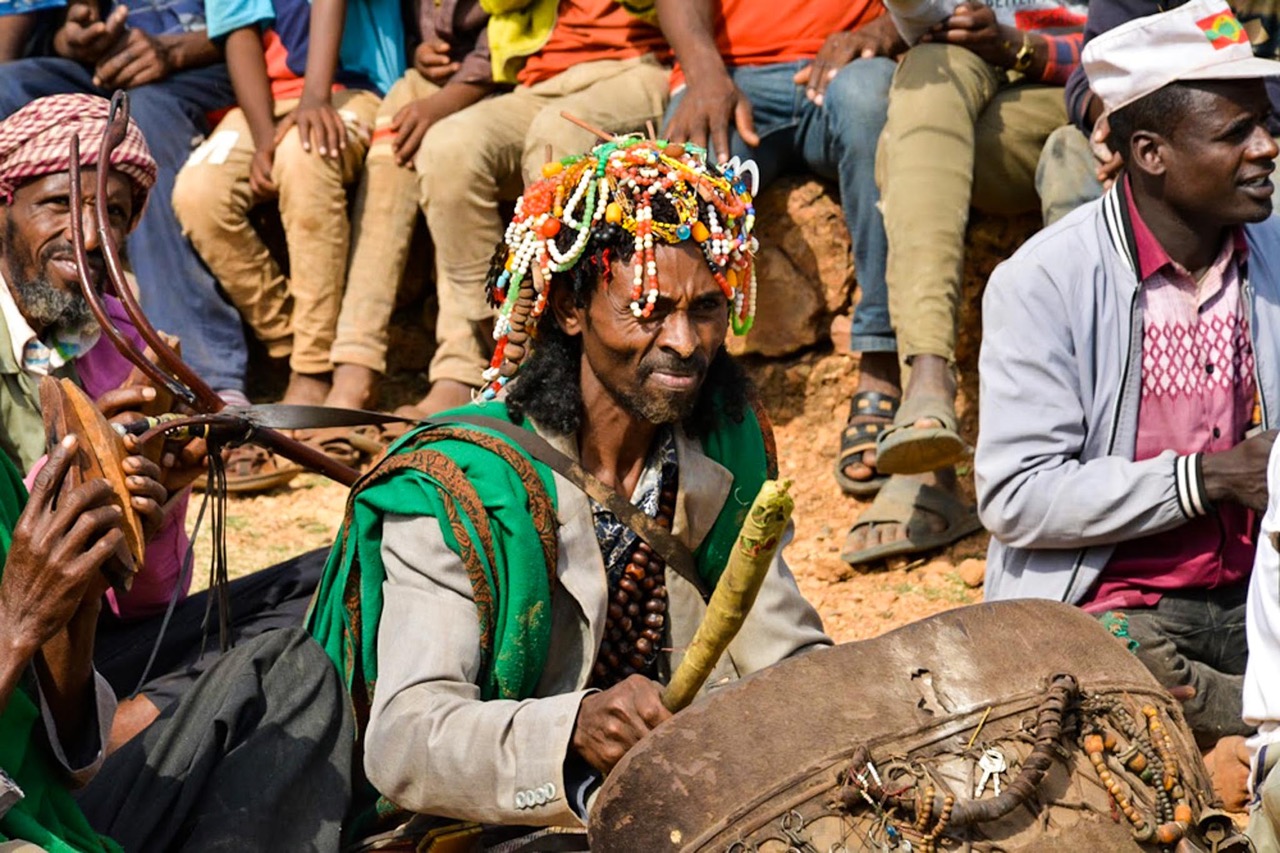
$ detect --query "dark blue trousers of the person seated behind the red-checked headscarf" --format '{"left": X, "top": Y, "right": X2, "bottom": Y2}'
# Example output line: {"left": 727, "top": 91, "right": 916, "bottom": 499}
{"left": 0, "top": 56, "right": 248, "bottom": 392}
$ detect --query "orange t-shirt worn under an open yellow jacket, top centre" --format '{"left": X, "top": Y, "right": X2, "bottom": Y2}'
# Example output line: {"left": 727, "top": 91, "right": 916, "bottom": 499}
{"left": 516, "top": 0, "right": 671, "bottom": 86}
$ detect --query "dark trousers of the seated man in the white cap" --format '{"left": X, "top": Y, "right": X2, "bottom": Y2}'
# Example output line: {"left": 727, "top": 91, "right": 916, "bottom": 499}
{"left": 1124, "top": 584, "right": 1253, "bottom": 748}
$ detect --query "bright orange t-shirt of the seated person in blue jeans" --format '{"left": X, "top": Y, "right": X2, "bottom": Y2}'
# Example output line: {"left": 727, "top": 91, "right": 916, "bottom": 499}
{"left": 671, "top": 0, "right": 884, "bottom": 88}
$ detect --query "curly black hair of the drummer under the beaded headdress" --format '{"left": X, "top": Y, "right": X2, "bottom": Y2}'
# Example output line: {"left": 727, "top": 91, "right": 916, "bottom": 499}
{"left": 504, "top": 212, "right": 751, "bottom": 438}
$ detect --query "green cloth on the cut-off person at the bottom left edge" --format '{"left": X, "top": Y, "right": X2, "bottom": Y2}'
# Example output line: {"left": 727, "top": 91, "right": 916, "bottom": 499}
{"left": 0, "top": 453, "right": 120, "bottom": 853}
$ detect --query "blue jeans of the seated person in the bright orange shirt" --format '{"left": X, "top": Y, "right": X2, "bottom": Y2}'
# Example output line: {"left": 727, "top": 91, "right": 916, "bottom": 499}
{"left": 667, "top": 58, "right": 897, "bottom": 352}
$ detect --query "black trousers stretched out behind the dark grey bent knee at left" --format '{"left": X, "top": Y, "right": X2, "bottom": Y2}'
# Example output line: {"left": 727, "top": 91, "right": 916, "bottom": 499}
{"left": 93, "top": 548, "right": 329, "bottom": 708}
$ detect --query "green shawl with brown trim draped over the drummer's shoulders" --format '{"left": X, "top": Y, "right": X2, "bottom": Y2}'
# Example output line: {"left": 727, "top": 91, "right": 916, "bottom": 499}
{"left": 307, "top": 402, "right": 776, "bottom": 836}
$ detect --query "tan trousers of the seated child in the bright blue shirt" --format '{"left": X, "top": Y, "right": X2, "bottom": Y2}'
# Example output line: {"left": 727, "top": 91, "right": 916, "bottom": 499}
{"left": 173, "top": 91, "right": 379, "bottom": 374}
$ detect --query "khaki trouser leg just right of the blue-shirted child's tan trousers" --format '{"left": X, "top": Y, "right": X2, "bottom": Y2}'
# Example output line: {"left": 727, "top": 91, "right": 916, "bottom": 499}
{"left": 332, "top": 68, "right": 442, "bottom": 376}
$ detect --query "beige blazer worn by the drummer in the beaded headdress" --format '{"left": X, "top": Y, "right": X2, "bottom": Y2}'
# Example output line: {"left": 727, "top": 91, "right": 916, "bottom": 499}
{"left": 365, "top": 422, "right": 831, "bottom": 826}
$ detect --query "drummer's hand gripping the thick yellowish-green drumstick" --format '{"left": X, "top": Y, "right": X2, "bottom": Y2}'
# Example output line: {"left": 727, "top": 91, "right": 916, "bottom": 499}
{"left": 570, "top": 675, "right": 671, "bottom": 774}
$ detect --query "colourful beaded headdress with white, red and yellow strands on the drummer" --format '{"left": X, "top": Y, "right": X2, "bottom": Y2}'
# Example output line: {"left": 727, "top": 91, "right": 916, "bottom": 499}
{"left": 480, "top": 136, "right": 759, "bottom": 400}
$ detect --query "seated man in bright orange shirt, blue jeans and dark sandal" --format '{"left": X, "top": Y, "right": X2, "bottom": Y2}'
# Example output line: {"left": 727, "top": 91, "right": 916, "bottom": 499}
{"left": 657, "top": 0, "right": 906, "bottom": 498}
